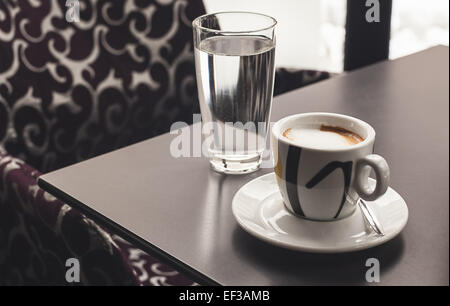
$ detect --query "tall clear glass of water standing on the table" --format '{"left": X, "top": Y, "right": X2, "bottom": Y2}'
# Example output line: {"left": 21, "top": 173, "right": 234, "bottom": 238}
{"left": 193, "top": 12, "right": 277, "bottom": 174}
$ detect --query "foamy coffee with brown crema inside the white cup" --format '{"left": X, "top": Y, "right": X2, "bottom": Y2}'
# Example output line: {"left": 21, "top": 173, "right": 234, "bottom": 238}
{"left": 283, "top": 124, "right": 364, "bottom": 149}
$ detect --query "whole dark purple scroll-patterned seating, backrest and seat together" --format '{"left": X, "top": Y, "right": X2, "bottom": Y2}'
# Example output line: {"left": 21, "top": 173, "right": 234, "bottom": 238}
{"left": 0, "top": 0, "right": 328, "bottom": 285}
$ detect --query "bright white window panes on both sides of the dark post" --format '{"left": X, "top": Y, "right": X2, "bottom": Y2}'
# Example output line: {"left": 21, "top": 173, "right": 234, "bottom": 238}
{"left": 204, "top": 0, "right": 449, "bottom": 72}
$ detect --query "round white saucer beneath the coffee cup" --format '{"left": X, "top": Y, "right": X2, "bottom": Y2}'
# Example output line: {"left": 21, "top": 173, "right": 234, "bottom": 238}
{"left": 232, "top": 173, "right": 408, "bottom": 253}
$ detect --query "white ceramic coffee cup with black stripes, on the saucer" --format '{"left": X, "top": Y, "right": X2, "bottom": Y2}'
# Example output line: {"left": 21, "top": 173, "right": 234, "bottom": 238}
{"left": 272, "top": 113, "right": 389, "bottom": 221}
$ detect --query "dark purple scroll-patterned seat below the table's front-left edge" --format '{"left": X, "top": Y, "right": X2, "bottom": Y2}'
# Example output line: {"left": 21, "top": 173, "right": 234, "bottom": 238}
{"left": 0, "top": 153, "right": 195, "bottom": 285}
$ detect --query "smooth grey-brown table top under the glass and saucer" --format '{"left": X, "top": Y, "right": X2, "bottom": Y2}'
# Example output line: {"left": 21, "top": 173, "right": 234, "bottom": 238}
{"left": 39, "top": 47, "right": 449, "bottom": 285}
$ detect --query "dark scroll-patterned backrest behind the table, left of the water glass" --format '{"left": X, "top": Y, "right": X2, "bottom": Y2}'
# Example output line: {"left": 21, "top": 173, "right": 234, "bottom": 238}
{"left": 0, "top": 0, "right": 204, "bottom": 171}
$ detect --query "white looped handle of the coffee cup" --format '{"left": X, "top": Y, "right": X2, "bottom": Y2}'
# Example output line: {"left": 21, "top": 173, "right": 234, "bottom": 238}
{"left": 355, "top": 154, "right": 389, "bottom": 201}
